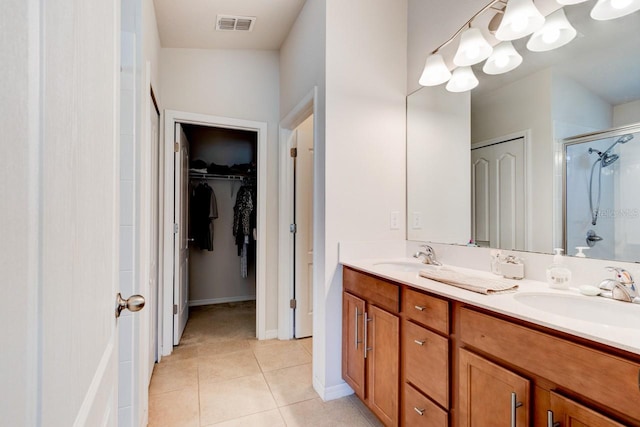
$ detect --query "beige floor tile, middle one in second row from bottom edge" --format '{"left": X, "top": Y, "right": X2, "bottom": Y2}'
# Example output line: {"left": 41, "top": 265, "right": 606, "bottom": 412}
{"left": 198, "top": 350, "right": 260, "bottom": 384}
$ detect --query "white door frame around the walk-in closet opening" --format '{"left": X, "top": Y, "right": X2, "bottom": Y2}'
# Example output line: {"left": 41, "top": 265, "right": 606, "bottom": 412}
{"left": 159, "top": 110, "right": 267, "bottom": 356}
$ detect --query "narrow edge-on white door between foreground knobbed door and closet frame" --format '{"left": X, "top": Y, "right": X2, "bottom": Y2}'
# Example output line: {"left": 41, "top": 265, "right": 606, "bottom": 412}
{"left": 147, "top": 93, "right": 161, "bottom": 374}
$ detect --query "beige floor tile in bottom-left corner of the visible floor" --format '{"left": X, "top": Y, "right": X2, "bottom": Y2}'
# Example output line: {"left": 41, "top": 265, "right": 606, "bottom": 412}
{"left": 149, "top": 387, "right": 200, "bottom": 427}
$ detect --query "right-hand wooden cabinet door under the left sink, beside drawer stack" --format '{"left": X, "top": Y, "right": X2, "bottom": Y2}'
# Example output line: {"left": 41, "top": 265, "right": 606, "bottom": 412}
{"left": 366, "top": 305, "right": 400, "bottom": 426}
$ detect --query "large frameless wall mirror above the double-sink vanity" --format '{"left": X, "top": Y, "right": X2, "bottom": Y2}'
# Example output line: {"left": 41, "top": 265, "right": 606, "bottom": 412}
{"left": 407, "top": 0, "right": 640, "bottom": 261}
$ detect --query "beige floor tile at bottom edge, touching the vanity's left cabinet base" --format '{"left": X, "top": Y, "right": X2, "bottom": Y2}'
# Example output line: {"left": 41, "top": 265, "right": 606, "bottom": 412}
{"left": 280, "top": 398, "right": 370, "bottom": 427}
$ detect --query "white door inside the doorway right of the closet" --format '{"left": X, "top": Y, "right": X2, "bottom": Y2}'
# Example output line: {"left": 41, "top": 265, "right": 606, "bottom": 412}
{"left": 294, "top": 116, "right": 313, "bottom": 338}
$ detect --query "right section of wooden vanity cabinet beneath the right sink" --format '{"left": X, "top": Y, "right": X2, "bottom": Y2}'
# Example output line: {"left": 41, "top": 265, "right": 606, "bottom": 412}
{"left": 455, "top": 306, "right": 640, "bottom": 427}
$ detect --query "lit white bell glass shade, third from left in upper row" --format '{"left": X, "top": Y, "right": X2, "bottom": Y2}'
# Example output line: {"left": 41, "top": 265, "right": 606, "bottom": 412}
{"left": 496, "top": 0, "right": 544, "bottom": 41}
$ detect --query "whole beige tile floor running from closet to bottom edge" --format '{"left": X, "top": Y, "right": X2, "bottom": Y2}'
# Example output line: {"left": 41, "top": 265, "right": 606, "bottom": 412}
{"left": 149, "top": 302, "right": 382, "bottom": 427}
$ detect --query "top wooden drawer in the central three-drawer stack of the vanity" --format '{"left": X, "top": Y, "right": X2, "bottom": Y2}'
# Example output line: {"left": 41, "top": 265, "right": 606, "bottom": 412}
{"left": 403, "top": 289, "right": 449, "bottom": 335}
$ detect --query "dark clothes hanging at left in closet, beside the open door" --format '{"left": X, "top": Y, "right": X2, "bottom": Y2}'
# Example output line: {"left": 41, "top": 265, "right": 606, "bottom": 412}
{"left": 189, "top": 181, "right": 218, "bottom": 251}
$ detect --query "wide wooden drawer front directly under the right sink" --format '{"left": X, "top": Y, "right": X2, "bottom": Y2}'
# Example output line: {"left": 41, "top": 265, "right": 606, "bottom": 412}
{"left": 460, "top": 308, "right": 640, "bottom": 420}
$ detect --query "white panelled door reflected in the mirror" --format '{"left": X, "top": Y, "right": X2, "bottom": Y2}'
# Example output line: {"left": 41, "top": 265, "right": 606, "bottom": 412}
{"left": 471, "top": 138, "right": 525, "bottom": 250}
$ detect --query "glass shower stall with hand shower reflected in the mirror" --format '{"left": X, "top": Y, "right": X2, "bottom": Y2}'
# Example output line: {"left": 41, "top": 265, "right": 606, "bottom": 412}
{"left": 563, "top": 125, "right": 640, "bottom": 261}
